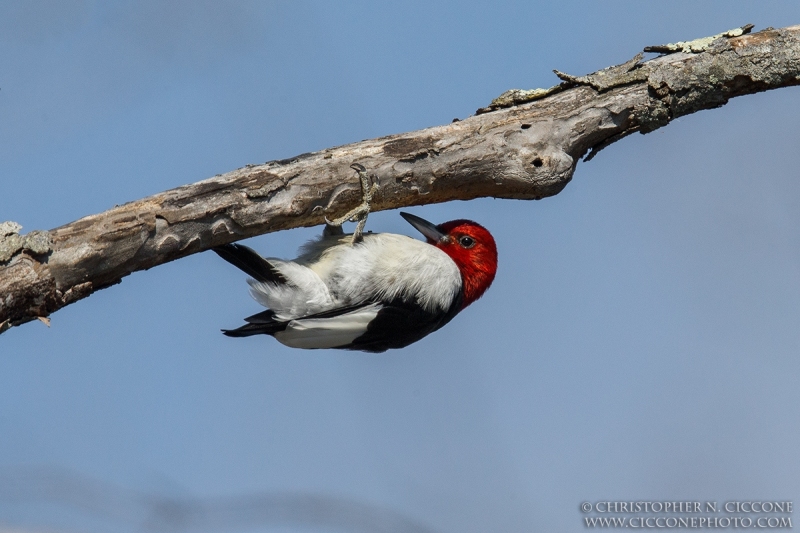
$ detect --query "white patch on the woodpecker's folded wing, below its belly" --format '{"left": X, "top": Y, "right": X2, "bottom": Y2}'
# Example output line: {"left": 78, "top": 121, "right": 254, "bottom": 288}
{"left": 275, "top": 304, "right": 382, "bottom": 349}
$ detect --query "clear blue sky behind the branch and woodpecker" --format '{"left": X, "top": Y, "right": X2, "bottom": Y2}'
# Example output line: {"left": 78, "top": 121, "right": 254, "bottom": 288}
{"left": 0, "top": 1, "right": 800, "bottom": 533}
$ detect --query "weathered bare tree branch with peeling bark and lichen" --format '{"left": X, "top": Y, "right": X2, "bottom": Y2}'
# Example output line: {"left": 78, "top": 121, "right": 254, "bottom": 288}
{"left": 0, "top": 26, "right": 800, "bottom": 332}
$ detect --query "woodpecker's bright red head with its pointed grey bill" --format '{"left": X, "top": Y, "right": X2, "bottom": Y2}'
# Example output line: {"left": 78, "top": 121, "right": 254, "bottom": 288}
{"left": 400, "top": 213, "right": 497, "bottom": 307}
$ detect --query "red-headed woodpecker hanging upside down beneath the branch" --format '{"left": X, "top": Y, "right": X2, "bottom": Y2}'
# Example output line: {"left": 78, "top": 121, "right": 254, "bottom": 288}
{"left": 214, "top": 213, "right": 497, "bottom": 352}
